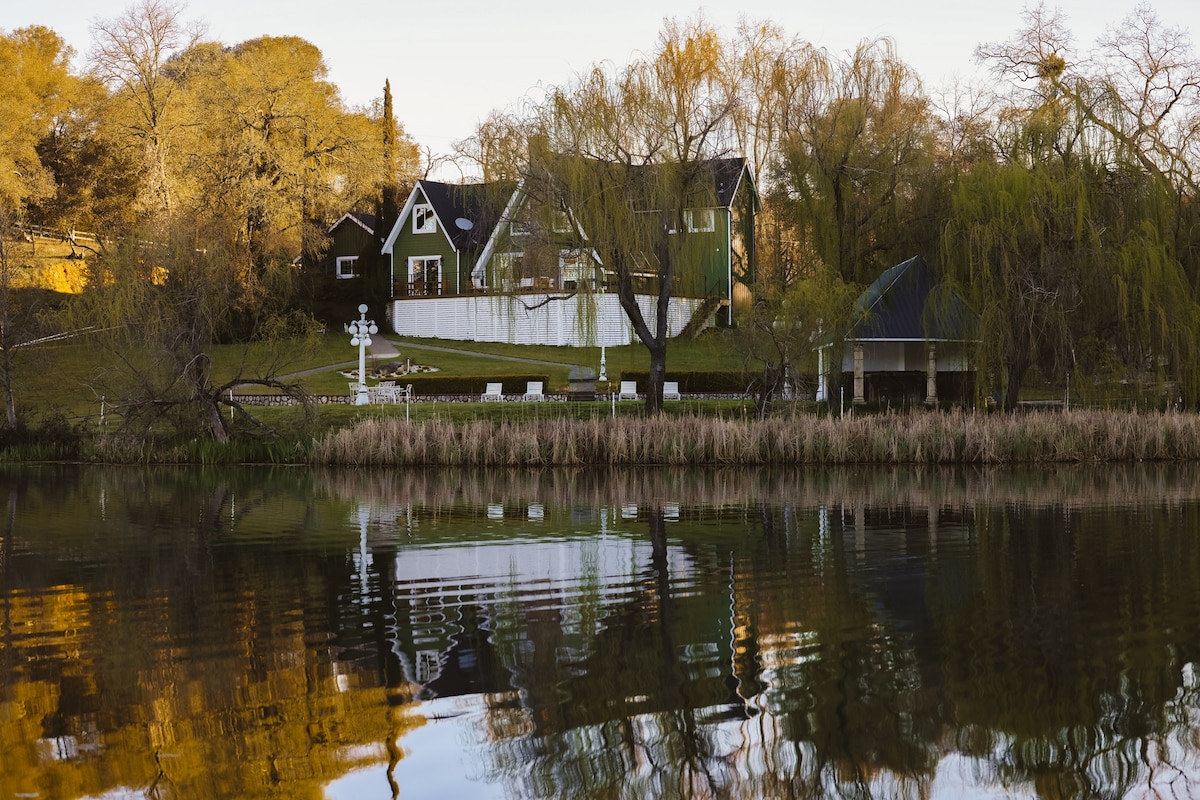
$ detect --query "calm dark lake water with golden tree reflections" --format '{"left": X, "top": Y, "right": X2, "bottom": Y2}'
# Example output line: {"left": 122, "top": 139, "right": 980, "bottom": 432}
{"left": 7, "top": 465, "right": 1200, "bottom": 800}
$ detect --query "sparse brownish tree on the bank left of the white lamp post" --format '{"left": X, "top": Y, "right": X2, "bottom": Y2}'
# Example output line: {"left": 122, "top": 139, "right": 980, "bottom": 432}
{"left": 62, "top": 221, "right": 320, "bottom": 443}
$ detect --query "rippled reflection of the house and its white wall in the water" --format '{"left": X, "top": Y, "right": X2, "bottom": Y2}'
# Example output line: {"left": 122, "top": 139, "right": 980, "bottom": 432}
{"left": 388, "top": 503, "right": 688, "bottom": 699}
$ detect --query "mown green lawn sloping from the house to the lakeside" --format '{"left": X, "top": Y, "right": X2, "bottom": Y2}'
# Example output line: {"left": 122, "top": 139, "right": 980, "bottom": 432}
{"left": 14, "top": 330, "right": 1171, "bottom": 453}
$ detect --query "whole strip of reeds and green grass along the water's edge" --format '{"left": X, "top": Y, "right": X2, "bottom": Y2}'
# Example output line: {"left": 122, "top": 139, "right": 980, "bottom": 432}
{"left": 11, "top": 404, "right": 1200, "bottom": 469}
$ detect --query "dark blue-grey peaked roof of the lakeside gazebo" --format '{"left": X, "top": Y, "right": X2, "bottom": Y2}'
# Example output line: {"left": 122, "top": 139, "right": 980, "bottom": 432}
{"left": 846, "top": 255, "right": 979, "bottom": 342}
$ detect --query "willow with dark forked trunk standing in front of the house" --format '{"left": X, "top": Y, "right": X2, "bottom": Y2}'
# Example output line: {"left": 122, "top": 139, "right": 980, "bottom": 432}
{"left": 526, "top": 22, "right": 737, "bottom": 413}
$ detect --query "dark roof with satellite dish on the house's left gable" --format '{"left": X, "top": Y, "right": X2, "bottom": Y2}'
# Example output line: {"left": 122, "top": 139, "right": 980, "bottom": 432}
{"left": 383, "top": 180, "right": 517, "bottom": 253}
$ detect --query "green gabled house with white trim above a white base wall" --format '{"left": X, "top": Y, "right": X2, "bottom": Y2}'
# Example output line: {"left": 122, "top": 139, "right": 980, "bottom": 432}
{"left": 369, "top": 158, "right": 758, "bottom": 345}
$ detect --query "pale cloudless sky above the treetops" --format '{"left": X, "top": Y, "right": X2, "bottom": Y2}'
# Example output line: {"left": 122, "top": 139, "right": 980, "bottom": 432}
{"left": 0, "top": 0, "right": 1200, "bottom": 166}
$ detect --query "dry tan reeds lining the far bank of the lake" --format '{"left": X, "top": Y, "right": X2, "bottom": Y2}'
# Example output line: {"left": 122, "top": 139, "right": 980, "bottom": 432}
{"left": 312, "top": 410, "right": 1200, "bottom": 467}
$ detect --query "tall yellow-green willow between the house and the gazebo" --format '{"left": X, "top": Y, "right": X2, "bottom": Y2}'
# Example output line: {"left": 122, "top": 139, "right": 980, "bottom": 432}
{"left": 772, "top": 40, "right": 938, "bottom": 283}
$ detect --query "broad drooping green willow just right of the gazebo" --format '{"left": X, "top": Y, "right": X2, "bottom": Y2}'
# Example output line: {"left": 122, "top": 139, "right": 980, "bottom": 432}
{"left": 944, "top": 143, "right": 1200, "bottom": 409}
